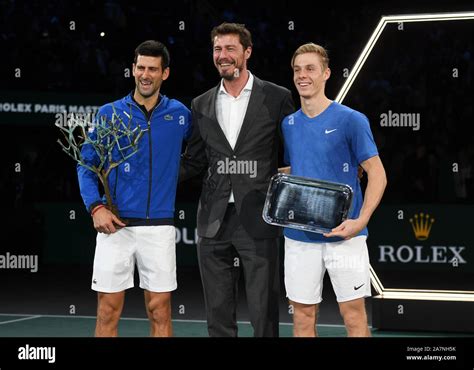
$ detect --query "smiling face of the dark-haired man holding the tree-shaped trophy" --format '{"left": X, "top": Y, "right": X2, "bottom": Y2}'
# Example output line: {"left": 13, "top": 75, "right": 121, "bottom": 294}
{"left": 133, "top": 55, "right": 169, "bottom": 99}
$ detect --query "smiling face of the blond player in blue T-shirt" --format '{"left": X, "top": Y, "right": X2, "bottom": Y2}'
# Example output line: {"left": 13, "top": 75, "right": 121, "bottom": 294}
{"left": 293, "top": 52, "right": 331, "bottom": 99}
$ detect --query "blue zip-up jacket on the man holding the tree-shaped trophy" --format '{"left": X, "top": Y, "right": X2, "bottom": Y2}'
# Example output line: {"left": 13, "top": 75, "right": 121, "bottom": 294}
{"left": 77, "top": 92, "right": 191, "bottom": 219}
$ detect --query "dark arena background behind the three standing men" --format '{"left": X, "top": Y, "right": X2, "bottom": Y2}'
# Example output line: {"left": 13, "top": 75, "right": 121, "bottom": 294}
{"left": 0, "top": 0, "right": 474, "bottom": 324}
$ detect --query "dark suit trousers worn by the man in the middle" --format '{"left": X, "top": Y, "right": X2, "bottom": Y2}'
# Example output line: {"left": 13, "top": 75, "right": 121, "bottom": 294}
{"left": 198, "top": 203, "right": 280, "bottom": 337}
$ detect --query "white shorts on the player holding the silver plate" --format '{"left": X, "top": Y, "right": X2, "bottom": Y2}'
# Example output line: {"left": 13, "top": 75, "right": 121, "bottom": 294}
{"left": 285, "top": 235, "right": 371, "bottom": 304}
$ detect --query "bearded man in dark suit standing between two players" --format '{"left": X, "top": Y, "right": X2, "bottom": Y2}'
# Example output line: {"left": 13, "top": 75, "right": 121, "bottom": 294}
{"left": 180, "top": 23, "right": 294, "bottom": 337}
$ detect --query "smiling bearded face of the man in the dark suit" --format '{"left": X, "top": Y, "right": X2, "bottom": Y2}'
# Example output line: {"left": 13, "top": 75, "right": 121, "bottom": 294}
{"left": 213, "top": 34, "right": 252, "bottom": 80}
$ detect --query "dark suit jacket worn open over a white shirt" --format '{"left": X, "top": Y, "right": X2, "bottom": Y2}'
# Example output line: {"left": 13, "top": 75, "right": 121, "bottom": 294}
{"left": 180, "top": 76, "right": 294, "bottom": 238}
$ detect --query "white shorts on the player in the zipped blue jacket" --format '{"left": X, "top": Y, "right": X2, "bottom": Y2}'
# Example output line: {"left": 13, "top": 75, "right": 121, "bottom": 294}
{"left": 92, "top": 225, "right": 178, "bottom": 293}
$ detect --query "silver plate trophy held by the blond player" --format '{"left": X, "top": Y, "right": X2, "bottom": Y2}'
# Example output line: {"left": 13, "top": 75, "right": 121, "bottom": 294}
{"left": 263, "top": 173, "right": 353, "bottom": 234}
